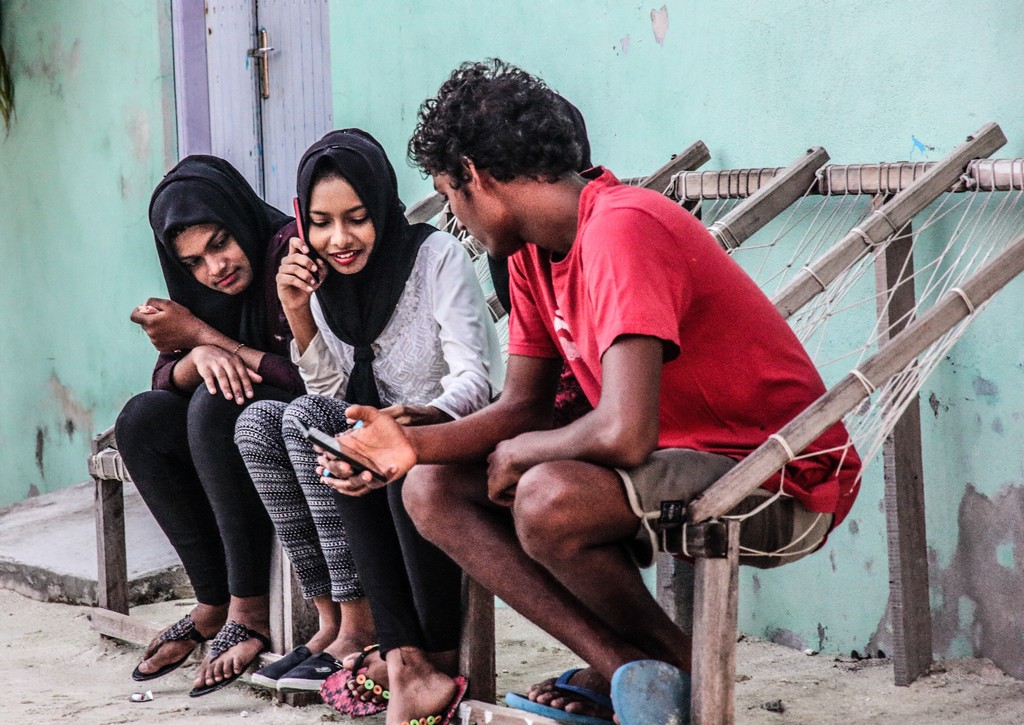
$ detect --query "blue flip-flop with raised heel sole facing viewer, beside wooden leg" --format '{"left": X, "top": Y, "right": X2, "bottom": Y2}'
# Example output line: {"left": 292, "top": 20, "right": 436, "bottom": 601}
{"left": 611, "top": 659, "right": 690, "bottom": 725}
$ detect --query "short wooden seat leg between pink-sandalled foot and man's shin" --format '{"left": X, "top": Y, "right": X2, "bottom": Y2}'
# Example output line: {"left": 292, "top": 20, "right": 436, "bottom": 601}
{"left": 459, "top": 574, "right": 496, "bottom": 702}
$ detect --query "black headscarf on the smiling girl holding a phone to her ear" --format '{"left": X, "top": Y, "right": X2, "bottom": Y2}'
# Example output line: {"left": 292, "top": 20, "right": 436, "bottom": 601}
{"left": 297, "top": 128, "right": 436, "bottom": 407}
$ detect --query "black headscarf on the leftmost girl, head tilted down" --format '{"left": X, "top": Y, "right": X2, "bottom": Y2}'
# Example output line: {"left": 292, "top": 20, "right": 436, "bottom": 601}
{"left": 150, "top": 156, "right": 291, "bottom": 350}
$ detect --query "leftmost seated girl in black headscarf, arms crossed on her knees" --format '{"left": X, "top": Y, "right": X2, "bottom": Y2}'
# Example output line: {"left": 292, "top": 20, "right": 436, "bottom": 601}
{"left": 116, "top": 156, "right": 321, "bottom": 695}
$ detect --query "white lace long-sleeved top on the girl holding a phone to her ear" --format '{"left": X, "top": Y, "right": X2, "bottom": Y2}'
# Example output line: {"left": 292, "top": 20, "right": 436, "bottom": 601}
{"left": 292, "top": 226, "right": 505, "bottom": 418}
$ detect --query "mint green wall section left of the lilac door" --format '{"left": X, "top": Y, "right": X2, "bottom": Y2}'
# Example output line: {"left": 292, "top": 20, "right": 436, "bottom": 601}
{"left": 0, "top": 0, "right": 174, "bottom": 505}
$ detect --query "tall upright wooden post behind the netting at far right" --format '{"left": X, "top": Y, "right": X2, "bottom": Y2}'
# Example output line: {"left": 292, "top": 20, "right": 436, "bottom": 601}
{"left": 874, "top": 198, "right": 932, "bottom": 685}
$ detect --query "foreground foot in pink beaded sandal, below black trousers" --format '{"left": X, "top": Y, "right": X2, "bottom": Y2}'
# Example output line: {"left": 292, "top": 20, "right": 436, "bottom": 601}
{"left": 386, "top": 647, "right": 459, "bottom": 725}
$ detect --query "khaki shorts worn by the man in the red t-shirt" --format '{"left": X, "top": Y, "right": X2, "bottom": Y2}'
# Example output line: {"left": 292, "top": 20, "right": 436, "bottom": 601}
{"left": 615, "top": 449, "right": 833, "bottom": 569}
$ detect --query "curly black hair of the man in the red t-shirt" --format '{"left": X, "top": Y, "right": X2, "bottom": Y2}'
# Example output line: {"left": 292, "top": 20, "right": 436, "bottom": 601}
{"left": 409, "top": 58, "right": 584, "bottom": 188}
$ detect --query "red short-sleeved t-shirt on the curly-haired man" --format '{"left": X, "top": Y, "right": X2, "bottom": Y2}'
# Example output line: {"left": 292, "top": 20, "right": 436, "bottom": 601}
{"left": 509, "top": 169, "right": 860, "bottom": 526}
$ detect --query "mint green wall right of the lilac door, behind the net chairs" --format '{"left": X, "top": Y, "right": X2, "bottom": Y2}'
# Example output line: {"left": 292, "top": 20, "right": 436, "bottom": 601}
{"left": 331, "top": 0, "right": 1024, "bottom": 677}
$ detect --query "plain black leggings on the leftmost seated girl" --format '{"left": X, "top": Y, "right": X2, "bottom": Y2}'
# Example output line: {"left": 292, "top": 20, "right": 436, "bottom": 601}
{"left": 115, "top": 385, "right": 295, "bottom": 606}
